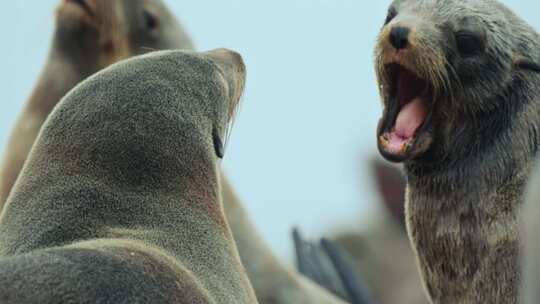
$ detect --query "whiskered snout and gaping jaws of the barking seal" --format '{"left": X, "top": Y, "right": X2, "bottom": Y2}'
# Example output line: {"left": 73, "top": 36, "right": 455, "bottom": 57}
{"left": 375, "top": 7, "right": 450, "bottom": 162}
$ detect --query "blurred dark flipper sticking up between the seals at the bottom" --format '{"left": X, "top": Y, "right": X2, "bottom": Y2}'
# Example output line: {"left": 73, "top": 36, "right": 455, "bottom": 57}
{"left": 293, "top": 229, "right": 373, "bottom": 304}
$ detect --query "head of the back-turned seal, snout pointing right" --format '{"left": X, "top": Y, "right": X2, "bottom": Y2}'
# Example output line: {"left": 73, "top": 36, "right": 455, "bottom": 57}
{"left": 39, "top": 49, "right": 246, "bottom": 185}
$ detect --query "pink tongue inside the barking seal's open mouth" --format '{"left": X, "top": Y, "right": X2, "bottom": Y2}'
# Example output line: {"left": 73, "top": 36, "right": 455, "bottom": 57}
{"left": 394, "top": 97, "right": 427, "bottom": 138}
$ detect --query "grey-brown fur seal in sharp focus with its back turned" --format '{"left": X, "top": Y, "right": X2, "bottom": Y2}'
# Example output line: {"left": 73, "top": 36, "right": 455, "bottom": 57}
{"left": 0, "top": 49, "right": 257, "bottom": 304}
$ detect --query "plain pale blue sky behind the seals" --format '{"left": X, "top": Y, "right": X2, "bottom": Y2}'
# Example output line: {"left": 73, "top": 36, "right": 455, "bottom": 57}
{"left": 0, "top": 0, "right": 540, "bottom": 257}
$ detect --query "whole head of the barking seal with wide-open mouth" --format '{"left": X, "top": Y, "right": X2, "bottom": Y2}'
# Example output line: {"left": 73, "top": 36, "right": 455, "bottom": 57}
{"left": 375, "top": 0, "right": 538, "bottom": 162}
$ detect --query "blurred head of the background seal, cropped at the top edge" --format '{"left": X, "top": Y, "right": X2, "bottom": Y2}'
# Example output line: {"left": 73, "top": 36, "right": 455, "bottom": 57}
{"left": 55, "top": 0, "right": 193, "bottom": 72}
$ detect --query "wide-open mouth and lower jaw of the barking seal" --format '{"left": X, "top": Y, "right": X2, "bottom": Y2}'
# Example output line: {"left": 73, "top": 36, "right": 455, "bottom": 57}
{"left": 377, "top": 63, "right": 433, "bottom": 162}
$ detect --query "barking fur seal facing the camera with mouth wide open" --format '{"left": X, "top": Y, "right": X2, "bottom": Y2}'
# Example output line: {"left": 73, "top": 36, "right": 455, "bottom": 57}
{"left": 375, "top": 0, "right": 540, "bottom": 304}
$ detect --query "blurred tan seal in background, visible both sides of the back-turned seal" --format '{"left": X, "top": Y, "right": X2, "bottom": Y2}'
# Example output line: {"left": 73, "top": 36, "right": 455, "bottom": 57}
{"left": 0, "top": 0, "right": 352, "bottom": 304}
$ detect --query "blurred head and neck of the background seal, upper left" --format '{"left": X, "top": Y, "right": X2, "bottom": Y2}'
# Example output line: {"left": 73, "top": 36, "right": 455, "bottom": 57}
{"left": 0, "top": 0, "right": 193, "bottom": 210}
